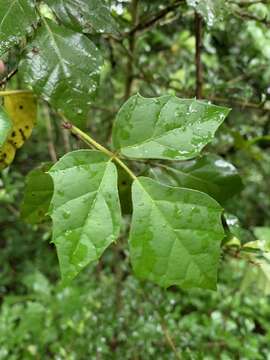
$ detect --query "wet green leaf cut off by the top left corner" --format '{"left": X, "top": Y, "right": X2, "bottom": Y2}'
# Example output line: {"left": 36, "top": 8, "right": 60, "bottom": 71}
{"left": 0, "top": 0, "right": 37, "bottom": 56}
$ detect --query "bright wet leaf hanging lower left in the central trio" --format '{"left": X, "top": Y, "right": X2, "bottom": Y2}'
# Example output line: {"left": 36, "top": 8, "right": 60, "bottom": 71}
{"left": 49, "top": 150, "right": 121, "bottom": 282}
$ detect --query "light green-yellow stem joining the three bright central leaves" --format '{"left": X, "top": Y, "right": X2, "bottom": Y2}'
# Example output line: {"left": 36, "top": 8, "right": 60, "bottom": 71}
{"left": 64, "top": 123, "right": 137, "bottom": 180}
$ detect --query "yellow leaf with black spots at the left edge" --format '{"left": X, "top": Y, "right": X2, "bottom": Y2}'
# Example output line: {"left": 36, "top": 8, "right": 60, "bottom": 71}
{"left": 0, "top": 92, "right": 37, "bottom": 169}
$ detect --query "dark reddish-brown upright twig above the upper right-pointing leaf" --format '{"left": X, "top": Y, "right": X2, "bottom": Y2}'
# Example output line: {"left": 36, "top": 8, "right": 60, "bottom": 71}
{"left": 195, "top": 12, "right": 203, "bottom": 99}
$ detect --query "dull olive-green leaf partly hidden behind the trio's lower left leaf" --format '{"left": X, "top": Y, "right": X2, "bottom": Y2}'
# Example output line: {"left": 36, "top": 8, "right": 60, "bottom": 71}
{"left": 21, "top": 163, "right": 53, "bottom": 224}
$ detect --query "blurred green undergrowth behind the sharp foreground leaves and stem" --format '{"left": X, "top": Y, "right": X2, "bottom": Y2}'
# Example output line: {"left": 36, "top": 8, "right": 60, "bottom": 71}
{"left": 0, "top": 0, "right": 270, "bottom": 359}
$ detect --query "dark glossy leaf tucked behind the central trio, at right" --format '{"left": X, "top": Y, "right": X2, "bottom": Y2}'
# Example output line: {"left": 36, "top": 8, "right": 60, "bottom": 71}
{"left": 149, "top": 154, "right": 243, "bottom": 204}
